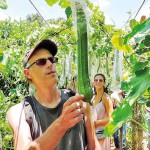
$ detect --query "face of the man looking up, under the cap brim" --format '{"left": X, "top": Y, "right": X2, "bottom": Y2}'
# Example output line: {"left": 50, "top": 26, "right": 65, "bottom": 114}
{"left": 24, "top": 49, "right": 58, "bottom": 86}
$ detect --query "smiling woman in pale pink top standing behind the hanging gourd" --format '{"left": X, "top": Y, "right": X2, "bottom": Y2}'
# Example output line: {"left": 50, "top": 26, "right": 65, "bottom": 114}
{"left": 91, "top": 74, "right": 113, "bottom": 150}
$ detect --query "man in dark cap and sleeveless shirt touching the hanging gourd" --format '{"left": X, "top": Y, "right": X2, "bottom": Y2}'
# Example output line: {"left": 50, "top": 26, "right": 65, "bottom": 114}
{"left": 7, "top": 40, "right": 95, "bottom": 150}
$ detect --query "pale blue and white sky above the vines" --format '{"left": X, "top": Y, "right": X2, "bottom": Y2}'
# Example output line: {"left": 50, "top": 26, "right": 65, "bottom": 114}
{"left": 0, "top": 0, "right": 150, "bottom": 28}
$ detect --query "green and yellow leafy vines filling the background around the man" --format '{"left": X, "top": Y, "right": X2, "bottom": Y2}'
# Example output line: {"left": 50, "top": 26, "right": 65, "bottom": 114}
{"left": 0, "top": 0, "right": 150, "bottom": 149}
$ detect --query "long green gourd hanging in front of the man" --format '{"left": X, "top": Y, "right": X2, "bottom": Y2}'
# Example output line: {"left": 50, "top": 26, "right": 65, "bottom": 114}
{"left": 76, "top": 3, "right": 93, "bottom": 104}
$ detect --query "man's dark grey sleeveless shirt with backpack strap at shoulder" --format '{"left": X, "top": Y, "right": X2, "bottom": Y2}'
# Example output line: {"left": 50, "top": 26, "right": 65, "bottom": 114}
{"left": 25, "top": 90, "right": 86, "bottom": 150}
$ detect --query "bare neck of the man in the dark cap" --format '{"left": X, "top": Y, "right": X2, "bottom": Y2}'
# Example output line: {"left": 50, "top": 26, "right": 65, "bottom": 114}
{"left": 35, "top": 86, "right": 61, "bottom": 108}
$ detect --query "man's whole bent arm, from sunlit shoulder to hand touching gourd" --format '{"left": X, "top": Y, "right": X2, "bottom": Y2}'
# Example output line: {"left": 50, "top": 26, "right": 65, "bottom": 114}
{"left": 7, "top": 95, "right": 85, "bottom": 150}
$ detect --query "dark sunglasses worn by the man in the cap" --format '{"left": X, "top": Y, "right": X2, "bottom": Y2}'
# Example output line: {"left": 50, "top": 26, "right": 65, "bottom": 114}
{"left": 27, "top": 57, "right": 58, "bottom": 69}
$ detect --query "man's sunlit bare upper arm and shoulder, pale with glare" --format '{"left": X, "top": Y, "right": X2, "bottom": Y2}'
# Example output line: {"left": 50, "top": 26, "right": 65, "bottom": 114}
{"left": 7, "top": 103, "right": 32, "bottom": 150}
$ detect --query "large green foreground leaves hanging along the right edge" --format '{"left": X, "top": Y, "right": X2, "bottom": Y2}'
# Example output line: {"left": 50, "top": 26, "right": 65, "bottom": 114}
{"left": 105, "top": 19, "right": 150, "bottom": 135}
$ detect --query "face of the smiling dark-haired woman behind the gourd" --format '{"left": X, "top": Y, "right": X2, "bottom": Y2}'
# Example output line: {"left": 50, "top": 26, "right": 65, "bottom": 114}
{"left": 94, "top": 75, "right": 105, "bottom": 89}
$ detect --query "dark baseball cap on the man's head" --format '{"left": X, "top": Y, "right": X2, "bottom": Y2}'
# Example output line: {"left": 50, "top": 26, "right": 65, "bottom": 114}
{"left": 23, "top": 39, "right": 58, "bottom": 68}
